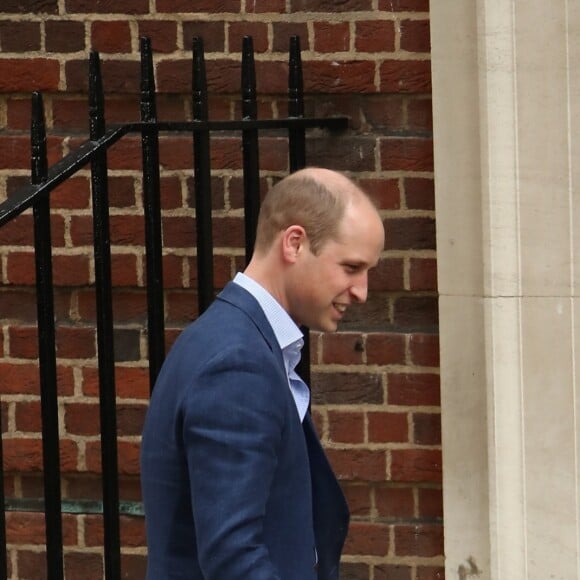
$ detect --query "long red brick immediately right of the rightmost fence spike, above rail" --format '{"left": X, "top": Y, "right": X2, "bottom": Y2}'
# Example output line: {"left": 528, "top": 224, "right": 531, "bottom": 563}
{"left": 304, "top": 60, "right": 376, "bottom": 93}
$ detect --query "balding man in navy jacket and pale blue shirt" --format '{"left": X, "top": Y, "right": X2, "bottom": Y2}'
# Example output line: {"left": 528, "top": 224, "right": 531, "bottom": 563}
{"left": 141, "top": 168, "right": 384, "bottom": 580}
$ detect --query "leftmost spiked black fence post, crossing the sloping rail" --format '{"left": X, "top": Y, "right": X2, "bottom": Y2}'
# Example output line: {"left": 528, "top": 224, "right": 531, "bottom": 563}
{"left": 31, "top": 93, "right": 64, "bottom": 580}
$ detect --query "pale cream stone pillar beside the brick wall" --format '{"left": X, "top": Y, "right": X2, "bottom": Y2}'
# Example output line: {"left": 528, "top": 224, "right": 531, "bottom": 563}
{"left": 431, "top": 0, "right": 580, "bottom": 580}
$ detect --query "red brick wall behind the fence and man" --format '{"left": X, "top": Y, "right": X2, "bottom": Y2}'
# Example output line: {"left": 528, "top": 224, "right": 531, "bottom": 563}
{"left": 0, "top": 0, "right": 443, "bottom": 580}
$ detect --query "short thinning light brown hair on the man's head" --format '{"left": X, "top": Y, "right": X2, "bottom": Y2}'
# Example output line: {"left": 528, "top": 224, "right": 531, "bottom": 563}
{"left": 256, "top": 168, "right": 364, "bottom": 254}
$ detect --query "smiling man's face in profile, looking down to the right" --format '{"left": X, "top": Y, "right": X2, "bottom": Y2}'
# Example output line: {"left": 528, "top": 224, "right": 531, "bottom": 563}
{"left": 287, "top": 202, "right": 384, "bottom": 331}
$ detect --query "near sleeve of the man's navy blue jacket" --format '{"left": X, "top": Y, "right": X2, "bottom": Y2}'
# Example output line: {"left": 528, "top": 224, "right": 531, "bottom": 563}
{"left": 182, "top": 345, "right": 285, "bottom": 580}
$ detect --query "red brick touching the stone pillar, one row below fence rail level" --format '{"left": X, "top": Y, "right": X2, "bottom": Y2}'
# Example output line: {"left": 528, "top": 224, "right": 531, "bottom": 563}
{"left": 379, "top": 137, "right": 433, "bottom": 171}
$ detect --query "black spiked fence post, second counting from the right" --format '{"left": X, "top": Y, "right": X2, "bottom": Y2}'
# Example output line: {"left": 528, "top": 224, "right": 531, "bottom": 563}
{"left": 242, "top": 36, "right": 260, "bottom": 262}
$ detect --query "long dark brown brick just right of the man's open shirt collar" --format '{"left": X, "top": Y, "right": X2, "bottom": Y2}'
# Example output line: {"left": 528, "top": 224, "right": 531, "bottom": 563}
{"left": 312, "top": 372, "right": 383, "bottom": 405}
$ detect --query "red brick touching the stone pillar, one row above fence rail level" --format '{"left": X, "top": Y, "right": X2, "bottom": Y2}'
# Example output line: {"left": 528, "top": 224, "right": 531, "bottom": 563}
{"left": 379, "top": 60, "right": 431, "bottom": 93}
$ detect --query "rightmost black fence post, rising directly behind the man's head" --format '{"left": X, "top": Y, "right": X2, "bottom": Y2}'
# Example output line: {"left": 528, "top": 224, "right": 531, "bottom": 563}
{"left": 288, "top": 36, "right": 310, "bottom": 385}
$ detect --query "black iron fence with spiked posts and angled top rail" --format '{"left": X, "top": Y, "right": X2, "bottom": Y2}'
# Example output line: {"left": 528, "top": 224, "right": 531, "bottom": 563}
{"left": 0, "top": 37, "right": 347, "bottom": 580}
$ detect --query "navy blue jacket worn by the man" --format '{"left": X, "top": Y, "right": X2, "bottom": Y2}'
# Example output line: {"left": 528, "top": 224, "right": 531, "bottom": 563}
{"left": 141, "top": 283, "right": 348, "bottom": 580}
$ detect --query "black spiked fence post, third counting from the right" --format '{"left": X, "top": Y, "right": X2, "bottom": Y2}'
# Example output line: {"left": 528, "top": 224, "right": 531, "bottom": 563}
{"left": 192, "top": 36, "right": 214, "bottom": 314}
